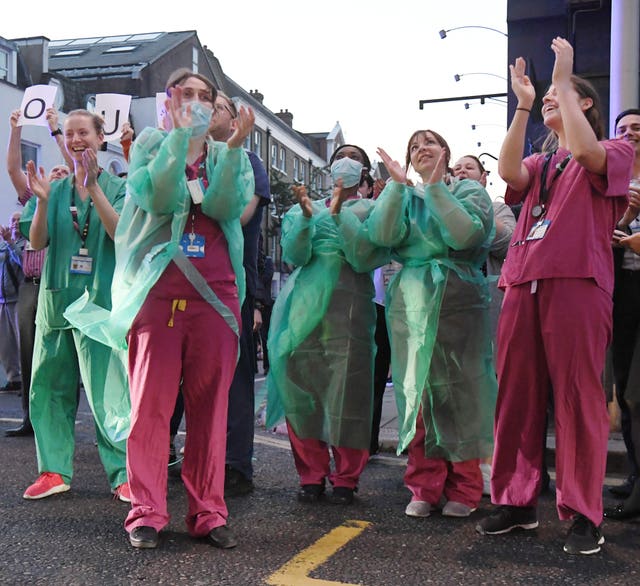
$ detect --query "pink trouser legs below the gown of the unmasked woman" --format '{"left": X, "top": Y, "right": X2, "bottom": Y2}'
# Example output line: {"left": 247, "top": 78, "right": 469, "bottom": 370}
{"left": 404, "top": 410, "right": 482, "bottom": 509}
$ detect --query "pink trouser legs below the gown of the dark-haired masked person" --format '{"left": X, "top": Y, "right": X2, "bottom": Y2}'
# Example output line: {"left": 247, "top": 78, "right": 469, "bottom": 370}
{"left": 287, "top": 421, "right": 369, "bottom": 489}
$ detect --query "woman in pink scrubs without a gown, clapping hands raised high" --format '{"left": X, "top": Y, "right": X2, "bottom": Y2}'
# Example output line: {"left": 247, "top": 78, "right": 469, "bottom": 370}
{"left": 476, "top": 37, "right": 634, "bottom": 554}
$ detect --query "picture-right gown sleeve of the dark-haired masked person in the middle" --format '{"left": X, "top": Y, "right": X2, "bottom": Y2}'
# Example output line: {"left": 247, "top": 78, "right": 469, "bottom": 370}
{"left": 338, "top": 200, "right": 391, "bottom": 273}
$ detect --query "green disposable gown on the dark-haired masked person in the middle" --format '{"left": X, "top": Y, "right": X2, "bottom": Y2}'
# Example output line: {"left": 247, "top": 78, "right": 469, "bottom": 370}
{"left": 267, "top": 200, "right": 390, "bottom": 449}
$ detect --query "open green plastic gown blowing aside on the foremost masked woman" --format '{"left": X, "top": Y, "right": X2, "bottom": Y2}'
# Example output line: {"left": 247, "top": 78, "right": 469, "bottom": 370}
{"left": 65, "top": 128, "right": 255, "bottom": 350}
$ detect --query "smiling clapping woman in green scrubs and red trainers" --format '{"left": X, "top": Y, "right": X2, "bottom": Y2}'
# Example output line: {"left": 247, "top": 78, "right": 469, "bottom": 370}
{"left": 20, "top": 110, "right": 130, "bottom": 502}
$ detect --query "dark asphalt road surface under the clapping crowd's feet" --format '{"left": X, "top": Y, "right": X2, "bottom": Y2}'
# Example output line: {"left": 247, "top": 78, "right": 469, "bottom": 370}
{"left": 0, "top": 394, "right": 640, "bottom": 586}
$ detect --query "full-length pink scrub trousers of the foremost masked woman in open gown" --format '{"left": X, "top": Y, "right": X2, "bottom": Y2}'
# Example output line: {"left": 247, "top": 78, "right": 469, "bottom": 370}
{"left": 125, "top": 276, "right": 240, "bottom": 537}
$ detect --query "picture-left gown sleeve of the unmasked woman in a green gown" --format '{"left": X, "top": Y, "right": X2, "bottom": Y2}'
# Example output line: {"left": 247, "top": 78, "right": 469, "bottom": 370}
{"left": 367, "top": 181, "right": 410, "bottom": 247}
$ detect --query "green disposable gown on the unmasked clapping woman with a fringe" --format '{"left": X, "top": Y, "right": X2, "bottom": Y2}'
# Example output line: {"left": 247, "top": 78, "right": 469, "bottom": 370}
{"left": 368, "top": 180, "right": 497, "bottom": 462}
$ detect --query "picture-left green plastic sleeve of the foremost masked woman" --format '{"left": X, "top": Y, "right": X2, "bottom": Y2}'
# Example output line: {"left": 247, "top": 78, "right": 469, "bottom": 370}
{"left": 127, "top": 128, "right": 191, "bottom": 214}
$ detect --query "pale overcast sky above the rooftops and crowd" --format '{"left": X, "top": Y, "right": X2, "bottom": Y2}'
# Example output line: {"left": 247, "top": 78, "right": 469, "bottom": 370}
{"left": 0, "top": 0, "right": 507, "bottom": 197}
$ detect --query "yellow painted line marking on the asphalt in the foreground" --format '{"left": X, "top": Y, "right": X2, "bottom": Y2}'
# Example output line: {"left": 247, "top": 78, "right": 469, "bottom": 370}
{"left": 267, "top": 521, "right": 371, "bottom": 586}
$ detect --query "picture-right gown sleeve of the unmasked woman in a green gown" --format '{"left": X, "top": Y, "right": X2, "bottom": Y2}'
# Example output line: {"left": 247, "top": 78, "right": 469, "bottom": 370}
{"left": 425, "top": 181, "right": 493, "bottom": 250}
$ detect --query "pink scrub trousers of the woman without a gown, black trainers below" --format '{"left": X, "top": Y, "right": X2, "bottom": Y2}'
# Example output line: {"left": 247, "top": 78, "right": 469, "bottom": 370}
{"left": 491, "top": 278, "right": 612, "bottom": 526}
